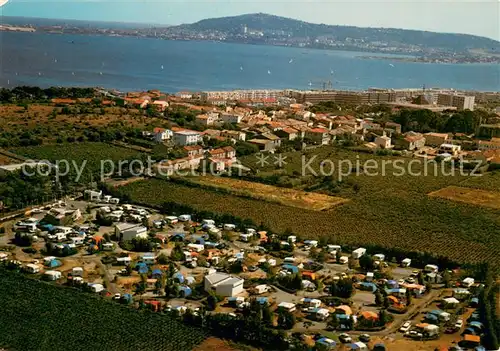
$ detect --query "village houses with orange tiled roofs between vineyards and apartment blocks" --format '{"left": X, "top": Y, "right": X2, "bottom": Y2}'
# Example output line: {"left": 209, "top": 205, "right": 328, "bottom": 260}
{"left": 150, "top": 100, "right": 500, "bottom": 163}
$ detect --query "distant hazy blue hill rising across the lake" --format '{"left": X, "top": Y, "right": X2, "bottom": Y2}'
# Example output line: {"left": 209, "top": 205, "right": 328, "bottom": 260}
{"left": 171, "top": 13, "right": 500, "bottom": 53}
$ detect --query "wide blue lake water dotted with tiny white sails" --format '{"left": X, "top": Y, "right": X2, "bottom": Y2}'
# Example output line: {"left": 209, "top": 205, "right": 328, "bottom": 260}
{"left": 0, "top": 32, "right": 500, "bottom": 92}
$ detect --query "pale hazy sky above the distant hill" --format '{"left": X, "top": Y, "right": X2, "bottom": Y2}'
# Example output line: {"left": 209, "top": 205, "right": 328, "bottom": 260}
{"left": 0, "top": 0, "right": 500, "bottom": 41}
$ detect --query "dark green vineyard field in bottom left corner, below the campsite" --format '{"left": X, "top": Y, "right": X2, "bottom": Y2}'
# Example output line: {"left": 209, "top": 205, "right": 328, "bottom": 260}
{"left": 0, "top": 269, "right": 206, "bottom": 351}
